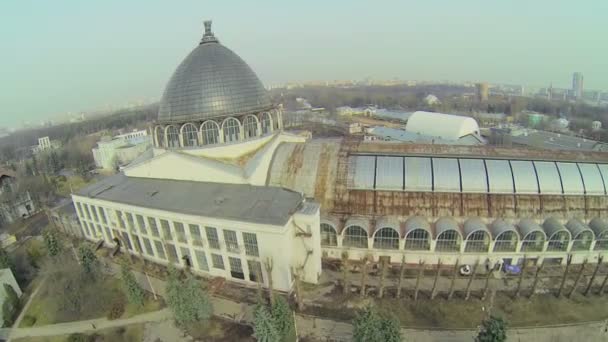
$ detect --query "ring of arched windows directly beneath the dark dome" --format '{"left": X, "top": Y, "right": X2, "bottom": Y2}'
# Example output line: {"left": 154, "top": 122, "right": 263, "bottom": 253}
{"left": 153, "top": 111, "right": 281, "bottom": 148}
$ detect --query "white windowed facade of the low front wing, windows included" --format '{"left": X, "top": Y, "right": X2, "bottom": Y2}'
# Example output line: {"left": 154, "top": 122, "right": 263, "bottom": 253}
{"left": 73, "top": 195, "right": 321, "bottom": 291}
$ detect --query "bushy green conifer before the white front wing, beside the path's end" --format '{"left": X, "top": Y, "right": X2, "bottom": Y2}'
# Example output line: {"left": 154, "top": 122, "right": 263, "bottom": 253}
{"left": 167, "top": 266, "right": 213, "bottom": 327}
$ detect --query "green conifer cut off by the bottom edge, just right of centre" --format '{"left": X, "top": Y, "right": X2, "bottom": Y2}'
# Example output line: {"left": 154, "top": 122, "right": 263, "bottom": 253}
{"left": 353, "top": 306, "right": 401, "bottom": 342}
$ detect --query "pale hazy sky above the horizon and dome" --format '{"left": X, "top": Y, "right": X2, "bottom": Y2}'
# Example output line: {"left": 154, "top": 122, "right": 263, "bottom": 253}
{"left": 0, "top": 0, "right": 608, "bottom": 126}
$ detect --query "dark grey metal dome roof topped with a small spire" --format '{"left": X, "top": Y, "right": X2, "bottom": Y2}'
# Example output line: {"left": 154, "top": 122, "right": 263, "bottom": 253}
{"left": 158, "top": 22, "right": 272, "bottom": 122}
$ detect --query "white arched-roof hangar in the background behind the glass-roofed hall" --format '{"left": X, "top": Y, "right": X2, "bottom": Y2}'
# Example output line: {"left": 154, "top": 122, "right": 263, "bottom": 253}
{"left": 405, "top": 111, "right": 479, "bottom": 140}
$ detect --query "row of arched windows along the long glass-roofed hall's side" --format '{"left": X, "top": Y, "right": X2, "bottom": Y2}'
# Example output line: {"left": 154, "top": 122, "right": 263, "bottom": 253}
{"left": 320, "top": 219, "right": 608, "bottom": 253}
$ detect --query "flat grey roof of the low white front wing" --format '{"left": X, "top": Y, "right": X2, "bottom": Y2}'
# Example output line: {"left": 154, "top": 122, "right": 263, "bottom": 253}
{"left": 76, "top": 174, "right": 304, "bottom": 226}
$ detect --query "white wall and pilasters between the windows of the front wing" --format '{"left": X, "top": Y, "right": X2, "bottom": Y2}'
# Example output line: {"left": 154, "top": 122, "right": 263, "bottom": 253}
{"left": 72, "top": 195, "right": 321, "bottom": 291}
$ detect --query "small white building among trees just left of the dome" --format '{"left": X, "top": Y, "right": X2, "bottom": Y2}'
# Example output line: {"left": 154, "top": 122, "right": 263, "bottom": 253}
{"left": 93, "top": 130, "right": 152, "bottom": 170}
